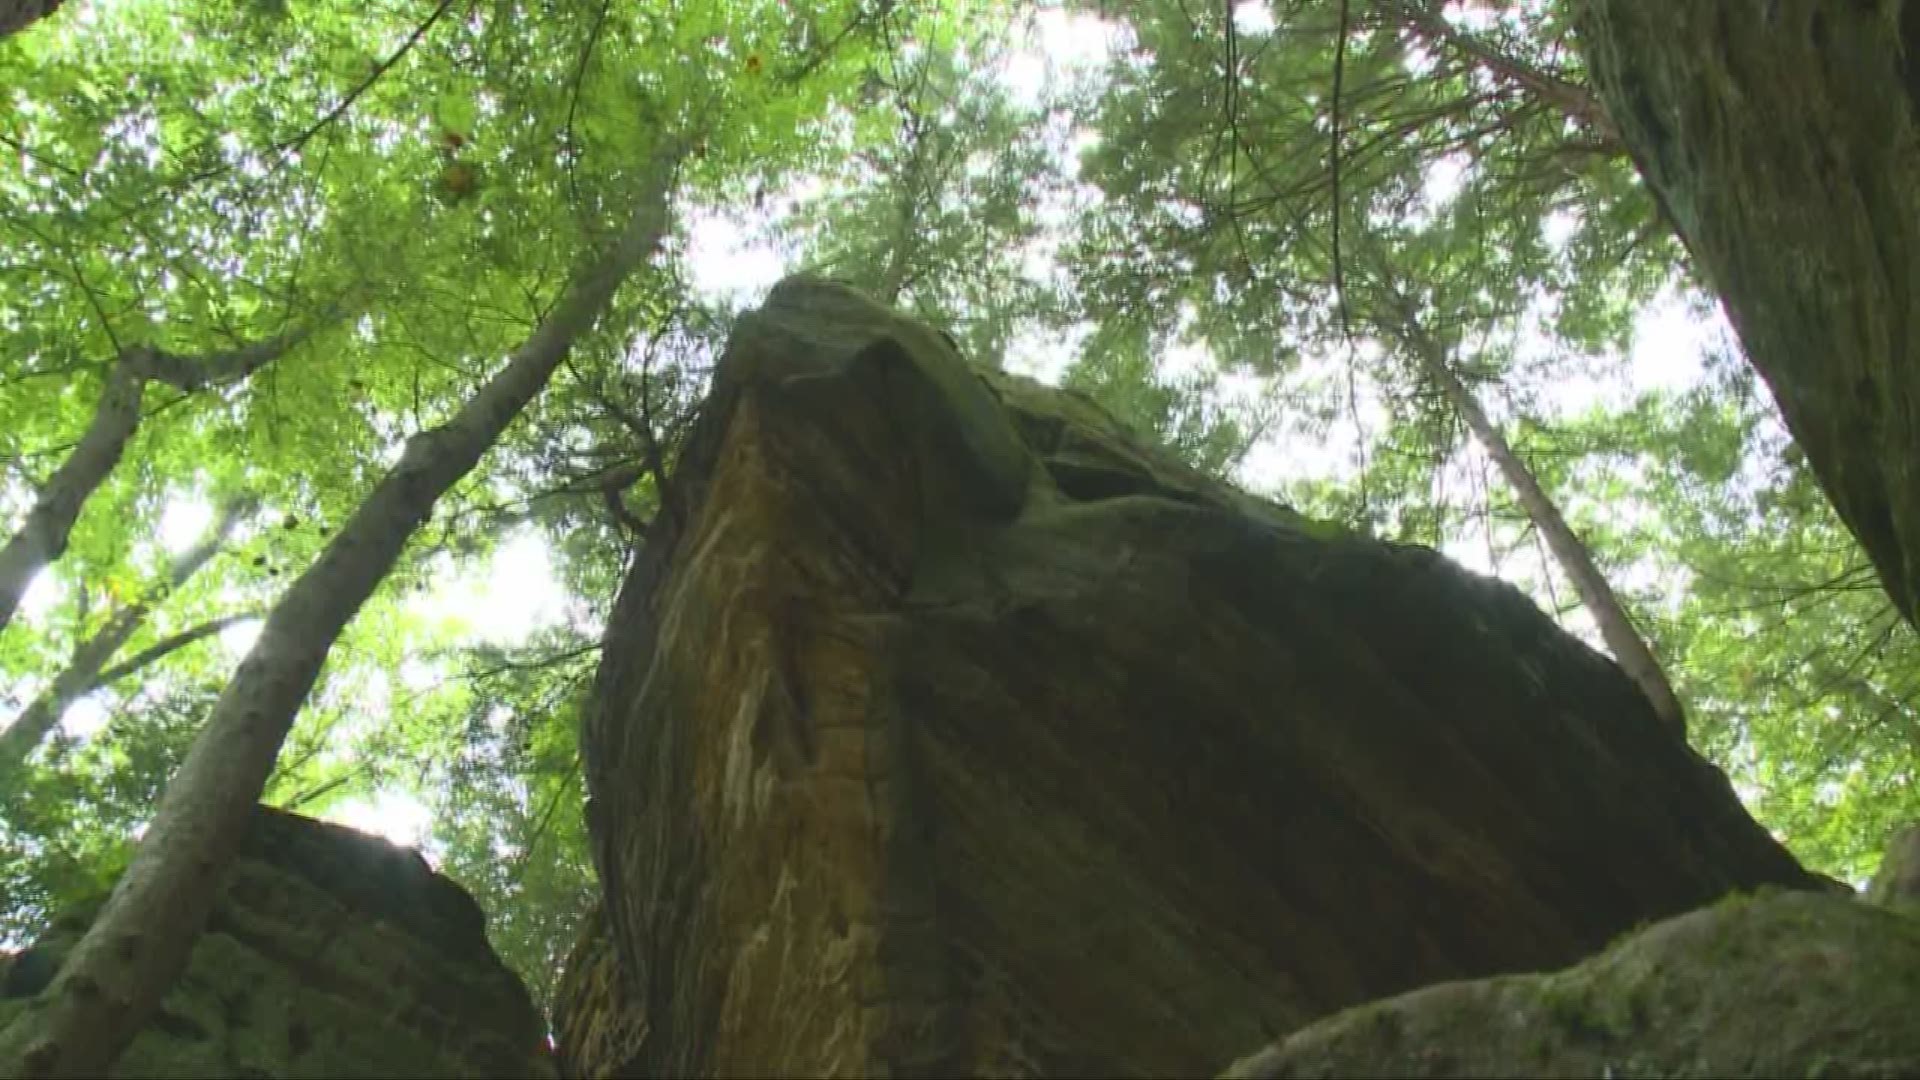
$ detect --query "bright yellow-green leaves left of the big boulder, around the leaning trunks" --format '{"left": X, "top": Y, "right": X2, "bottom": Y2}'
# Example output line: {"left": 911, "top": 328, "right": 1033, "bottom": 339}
{"left": 0, "top": 0, "right": 877, "bottom": 976}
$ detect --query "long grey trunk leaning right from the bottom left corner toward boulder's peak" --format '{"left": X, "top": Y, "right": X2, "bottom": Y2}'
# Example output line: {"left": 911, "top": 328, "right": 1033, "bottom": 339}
{"left": 0, "top": 142, "right": 680, "bottom": 1076}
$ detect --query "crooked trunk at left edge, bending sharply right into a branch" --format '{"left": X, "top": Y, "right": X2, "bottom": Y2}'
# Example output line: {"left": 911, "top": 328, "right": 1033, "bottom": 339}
{"left": 0, "top": 327, "right": 311, "bottom": 630}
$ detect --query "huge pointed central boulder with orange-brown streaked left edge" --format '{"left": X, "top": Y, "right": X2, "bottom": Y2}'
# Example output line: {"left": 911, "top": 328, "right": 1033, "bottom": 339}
{"left": 561, "top": 279, "right": 1816, "bottom": 1076}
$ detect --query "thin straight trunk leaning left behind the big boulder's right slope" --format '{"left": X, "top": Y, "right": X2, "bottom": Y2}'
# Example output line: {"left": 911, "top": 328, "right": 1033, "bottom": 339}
{"left": 1398, "top": 319, "right": 1686, "bottom": 738}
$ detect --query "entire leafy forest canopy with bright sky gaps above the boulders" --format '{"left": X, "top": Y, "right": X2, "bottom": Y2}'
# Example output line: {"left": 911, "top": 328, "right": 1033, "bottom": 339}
{"left": 0, "top": 0, "right": 1920, "bottom": 1022}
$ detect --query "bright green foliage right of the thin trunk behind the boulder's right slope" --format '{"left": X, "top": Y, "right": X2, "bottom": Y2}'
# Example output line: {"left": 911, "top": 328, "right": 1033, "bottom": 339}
{"left": 1543, "top": 356, "right": 1920, "bottom": 882}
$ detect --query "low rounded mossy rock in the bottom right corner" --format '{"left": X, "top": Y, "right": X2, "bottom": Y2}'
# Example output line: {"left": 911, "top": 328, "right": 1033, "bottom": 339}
{"left": 1227, "top": 894, "right": 1920, "bottom": 1080}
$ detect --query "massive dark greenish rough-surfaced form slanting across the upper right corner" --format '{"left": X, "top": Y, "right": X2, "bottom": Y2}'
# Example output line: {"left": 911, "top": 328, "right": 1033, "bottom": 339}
{"left": 1578, "top": 0, "right": 1920, "bottom": 625}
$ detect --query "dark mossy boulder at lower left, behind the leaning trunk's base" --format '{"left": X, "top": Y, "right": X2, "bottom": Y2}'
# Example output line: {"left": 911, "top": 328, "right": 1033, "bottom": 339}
{"left": 0, "top": 807, "right": 553, "bottom": 1076}
